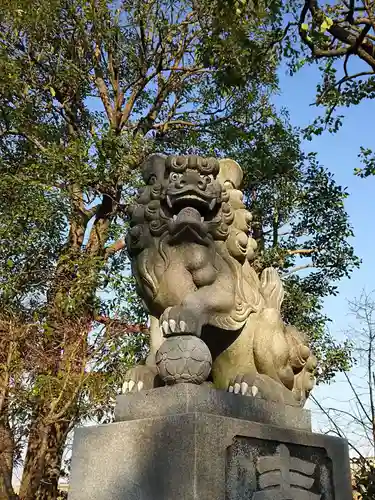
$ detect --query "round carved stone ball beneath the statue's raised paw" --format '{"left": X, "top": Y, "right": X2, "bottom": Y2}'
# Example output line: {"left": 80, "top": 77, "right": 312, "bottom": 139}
{"left": 156, "top": 335, "right": 212, "bottom": 385}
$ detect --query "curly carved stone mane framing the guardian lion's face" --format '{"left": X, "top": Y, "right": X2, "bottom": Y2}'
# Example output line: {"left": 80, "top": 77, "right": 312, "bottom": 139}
{"left": 127, "top": 155, "right": 283, "bottom": 330}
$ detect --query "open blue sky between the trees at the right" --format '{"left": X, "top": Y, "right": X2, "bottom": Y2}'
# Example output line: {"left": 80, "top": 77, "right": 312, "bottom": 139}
{"left": 275, "top": 60, "right": 375, "bottom": 449}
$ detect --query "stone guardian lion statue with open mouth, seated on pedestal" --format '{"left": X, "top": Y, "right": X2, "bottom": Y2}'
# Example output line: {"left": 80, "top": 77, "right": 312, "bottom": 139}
{"left": 125, "top": 155, "right": 316, "bottom": 405}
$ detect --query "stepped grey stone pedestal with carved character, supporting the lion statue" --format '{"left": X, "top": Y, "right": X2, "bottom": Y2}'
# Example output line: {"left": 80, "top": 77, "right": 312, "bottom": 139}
{"left": 69, "top": 384, "right": 352, "bottom": 500}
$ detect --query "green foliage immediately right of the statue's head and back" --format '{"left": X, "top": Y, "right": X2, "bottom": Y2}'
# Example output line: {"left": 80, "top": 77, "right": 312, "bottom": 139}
{"left": 244, "top": 123, "right": 359, "bottom": 381}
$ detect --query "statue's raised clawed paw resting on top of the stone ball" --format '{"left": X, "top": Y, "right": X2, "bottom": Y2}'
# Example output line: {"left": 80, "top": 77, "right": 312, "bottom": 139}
{"left": 159, "top": 306, "right": 201, "bottom": 337}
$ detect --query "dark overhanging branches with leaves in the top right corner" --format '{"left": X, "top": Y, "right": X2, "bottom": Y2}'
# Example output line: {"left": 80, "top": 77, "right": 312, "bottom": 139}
{"left": 281, "top": 0, "right": 375, "bottom": 177}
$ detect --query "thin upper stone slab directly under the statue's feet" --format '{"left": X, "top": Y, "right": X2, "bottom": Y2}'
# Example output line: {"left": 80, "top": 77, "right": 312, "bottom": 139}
{"left": 115, "top": 384, "right": 311, "bottom": 431}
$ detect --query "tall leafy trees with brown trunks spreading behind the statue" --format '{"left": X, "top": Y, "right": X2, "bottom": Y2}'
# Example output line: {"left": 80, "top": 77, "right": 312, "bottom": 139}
{"left": 0, "top": 0, "right": 357, "bottom": 500}
